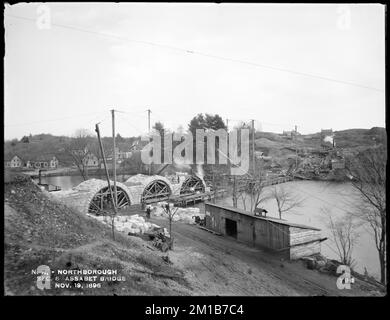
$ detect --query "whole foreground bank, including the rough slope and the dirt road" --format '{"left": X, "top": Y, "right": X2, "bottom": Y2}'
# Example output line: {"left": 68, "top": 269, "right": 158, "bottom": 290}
{"left": 4, "top": 174, "right": 383, "bottom": 296}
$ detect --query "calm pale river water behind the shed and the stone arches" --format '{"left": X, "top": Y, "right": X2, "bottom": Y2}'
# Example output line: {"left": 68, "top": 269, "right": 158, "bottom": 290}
{"left": 42, "top": 175, "right": 380, "bottom": 278}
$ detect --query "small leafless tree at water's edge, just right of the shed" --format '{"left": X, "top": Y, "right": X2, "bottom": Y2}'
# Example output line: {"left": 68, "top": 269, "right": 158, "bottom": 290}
{"left": 322, "top": 209, "right": 359, "bottom": 267}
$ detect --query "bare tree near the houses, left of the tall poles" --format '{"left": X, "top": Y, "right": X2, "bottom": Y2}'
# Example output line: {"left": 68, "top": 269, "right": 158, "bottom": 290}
{"left": 65, "top": 129, "right": 93, "bottom": 180}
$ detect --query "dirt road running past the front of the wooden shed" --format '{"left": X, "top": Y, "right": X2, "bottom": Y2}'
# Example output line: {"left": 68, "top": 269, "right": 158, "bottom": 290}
{"left": 151, "top": 217, "right": 373, "bottom": 296}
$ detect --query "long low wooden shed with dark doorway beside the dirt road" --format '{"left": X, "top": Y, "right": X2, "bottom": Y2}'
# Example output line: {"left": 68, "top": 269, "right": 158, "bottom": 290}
{"left": 205, "top": 202, "right": 326, "bottom": 260}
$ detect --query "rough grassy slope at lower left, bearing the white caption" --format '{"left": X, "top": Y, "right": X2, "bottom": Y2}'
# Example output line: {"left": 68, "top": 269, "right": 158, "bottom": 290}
{"left": 4, "top": 177, "right": 191, "bottom": 295}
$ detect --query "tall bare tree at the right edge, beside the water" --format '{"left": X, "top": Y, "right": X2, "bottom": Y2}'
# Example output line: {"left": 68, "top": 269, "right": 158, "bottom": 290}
{"left": 347, "top": 145, "right": 387, "bottom": 284}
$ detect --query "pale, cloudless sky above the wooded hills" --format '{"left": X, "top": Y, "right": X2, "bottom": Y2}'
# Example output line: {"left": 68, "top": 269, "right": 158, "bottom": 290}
{"left": 4, "top": 3, "right": 385, "bottom": 139}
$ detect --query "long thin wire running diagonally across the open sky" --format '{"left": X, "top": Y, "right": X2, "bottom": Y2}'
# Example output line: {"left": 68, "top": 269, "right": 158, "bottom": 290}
{"left": 5, "top": 15, "right": 384, "bottom": 92}
